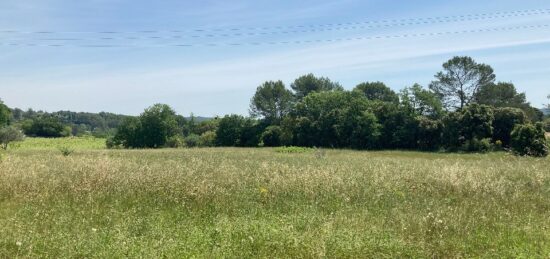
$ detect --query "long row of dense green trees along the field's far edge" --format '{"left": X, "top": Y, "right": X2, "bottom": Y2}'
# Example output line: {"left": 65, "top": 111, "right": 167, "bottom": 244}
{"left": 1, "top": 57, "right": 550, "bottom": 156}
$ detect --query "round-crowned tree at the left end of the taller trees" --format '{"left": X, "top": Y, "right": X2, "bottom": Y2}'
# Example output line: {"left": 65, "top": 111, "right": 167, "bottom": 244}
{"left": 250, "top": 81, "right": 294, "bottom": 123}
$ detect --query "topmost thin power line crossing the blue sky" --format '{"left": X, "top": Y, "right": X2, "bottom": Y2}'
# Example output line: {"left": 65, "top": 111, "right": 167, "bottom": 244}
{"left": 0, "top": 9, "right": 550, "bottom": 36}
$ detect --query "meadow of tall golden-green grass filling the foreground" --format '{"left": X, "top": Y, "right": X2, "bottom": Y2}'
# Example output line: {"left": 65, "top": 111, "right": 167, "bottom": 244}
{"left": 0, "top": 140, "right": 550, "bottom": 258}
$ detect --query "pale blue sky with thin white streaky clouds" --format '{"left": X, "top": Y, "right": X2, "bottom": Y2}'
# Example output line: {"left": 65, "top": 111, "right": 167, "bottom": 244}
{"left": 0, "top": 0, "right": 550, "bottom": 116}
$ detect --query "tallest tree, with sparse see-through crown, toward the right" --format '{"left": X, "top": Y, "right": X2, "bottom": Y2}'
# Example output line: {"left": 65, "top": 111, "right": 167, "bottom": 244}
{"left": 430, "top": 57, "right": 495, "bottom": 109}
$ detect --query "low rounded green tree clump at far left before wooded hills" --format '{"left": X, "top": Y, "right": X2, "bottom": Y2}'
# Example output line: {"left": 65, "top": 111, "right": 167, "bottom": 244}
{"left": 22, "top": 116, "right": 71, "bottom": 138}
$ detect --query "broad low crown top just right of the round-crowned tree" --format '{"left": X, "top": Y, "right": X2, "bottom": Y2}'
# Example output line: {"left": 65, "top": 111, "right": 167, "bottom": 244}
{"left": 290, "top": 74, "right": 344, "bottom": 100}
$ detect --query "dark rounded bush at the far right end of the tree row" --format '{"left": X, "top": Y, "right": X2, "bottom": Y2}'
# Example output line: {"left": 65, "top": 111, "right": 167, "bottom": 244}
{"left": 511, "top": 123, "right": 548, "bottom": 157}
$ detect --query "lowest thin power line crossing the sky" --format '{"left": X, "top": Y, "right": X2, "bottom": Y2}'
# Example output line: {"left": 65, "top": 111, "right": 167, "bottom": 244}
{"left": 0, "top": 24, "right": 550, "bottom": 48}
